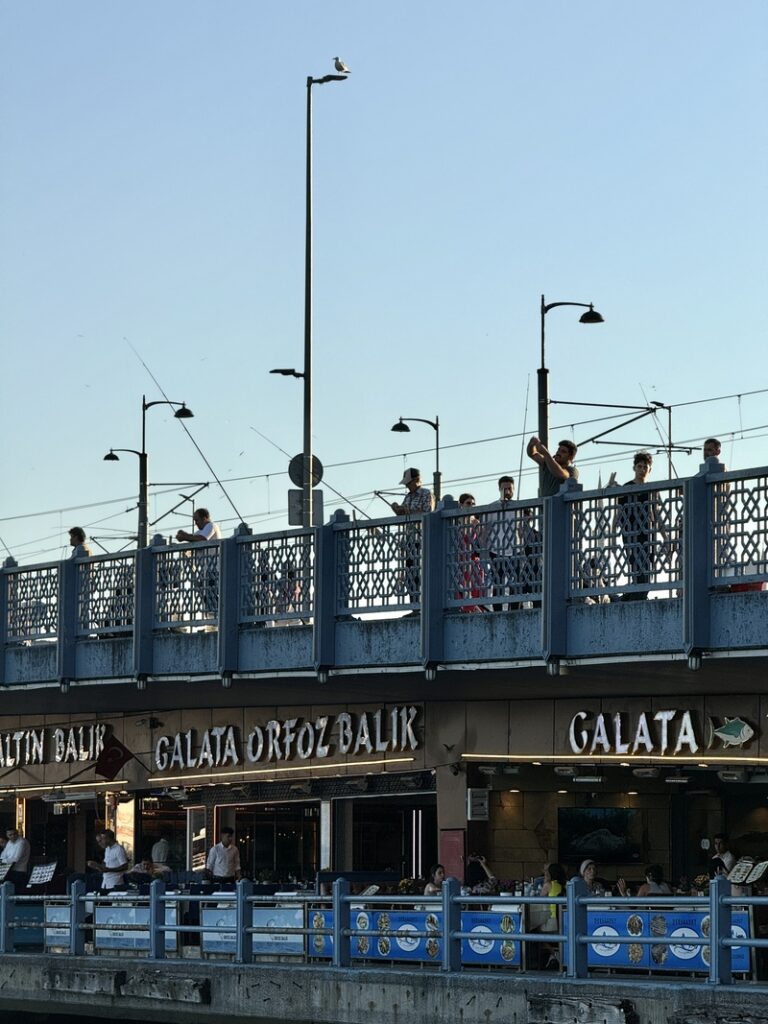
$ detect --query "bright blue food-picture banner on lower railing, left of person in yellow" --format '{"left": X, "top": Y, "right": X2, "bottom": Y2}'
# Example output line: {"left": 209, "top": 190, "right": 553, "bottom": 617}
{"left": 309, "top": 907, "right": 522, "bottom": 967}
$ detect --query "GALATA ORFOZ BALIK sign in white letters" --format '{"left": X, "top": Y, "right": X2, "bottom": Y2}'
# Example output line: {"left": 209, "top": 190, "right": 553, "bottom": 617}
{"left": 155, "top": 707, "right": 419, "bottom": 771}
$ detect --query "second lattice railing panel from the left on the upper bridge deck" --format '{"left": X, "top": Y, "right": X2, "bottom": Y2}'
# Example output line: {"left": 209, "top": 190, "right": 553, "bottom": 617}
{"left": 77, "top": 553, "right": 136, "bottom": 636}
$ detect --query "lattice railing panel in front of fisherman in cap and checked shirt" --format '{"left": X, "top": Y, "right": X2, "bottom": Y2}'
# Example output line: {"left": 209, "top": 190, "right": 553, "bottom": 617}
{"left": 336, "top": 516, "right": 422, "bottom": 614}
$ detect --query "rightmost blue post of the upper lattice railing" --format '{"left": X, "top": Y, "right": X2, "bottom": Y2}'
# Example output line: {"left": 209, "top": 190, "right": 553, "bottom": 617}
{"left": 683, "top": 459, "right": 725, "bottom": 658}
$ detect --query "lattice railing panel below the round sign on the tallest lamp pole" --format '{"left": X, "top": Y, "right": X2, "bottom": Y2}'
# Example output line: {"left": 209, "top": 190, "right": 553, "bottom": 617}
{"left": 239, "top": 532, "right": 314, "bottom": 623}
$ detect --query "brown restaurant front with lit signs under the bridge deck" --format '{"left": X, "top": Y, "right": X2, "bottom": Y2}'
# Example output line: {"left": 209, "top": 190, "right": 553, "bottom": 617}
{"left": 6, "top": 673, "right": 768, "bottom": 883}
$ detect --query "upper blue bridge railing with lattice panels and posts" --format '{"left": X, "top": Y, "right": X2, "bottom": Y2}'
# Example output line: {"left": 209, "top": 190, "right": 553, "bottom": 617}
{"left": 0, "top": 460, "right": 768, "bottom": 682}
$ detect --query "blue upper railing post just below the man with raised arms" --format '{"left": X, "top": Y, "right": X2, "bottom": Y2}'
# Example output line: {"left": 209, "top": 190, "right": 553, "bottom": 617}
{"left": 542, "top": 479, "right": 583, "bottom": 664}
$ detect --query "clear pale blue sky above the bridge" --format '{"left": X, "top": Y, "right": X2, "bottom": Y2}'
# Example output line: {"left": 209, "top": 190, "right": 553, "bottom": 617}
{"left": 0, "top": 0, "right": 768, "bottom": 564}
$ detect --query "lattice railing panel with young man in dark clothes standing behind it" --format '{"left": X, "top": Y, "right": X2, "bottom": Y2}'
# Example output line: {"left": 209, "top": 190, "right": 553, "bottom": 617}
{"left": 568, "top": 483, "right": 683, "bottom": 600}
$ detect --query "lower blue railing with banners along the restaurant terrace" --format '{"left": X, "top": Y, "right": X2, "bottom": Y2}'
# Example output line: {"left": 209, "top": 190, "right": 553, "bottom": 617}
{"left": 0, "top": 878, "right": 753, "bottom": 986}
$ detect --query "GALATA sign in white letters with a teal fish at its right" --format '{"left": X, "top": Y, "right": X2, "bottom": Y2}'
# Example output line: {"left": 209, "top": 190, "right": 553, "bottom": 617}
{"left": 568, "top": 710, "right": 755, "bottom": 757}
